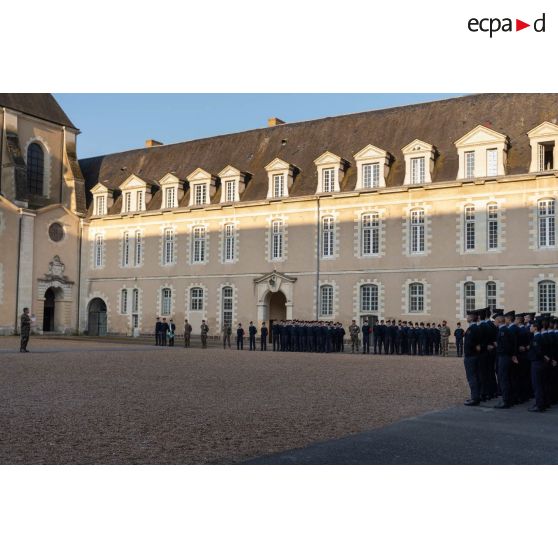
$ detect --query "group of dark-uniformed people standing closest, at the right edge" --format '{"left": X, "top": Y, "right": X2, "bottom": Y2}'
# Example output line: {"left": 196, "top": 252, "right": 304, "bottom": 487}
{"left": 464, "top": 308, "right": 558, "bottom": 412}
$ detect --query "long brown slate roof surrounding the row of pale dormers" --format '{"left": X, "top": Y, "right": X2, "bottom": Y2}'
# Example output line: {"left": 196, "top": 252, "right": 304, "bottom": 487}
{"left": 80, "top": 93, "right": 558, "bottom": 213}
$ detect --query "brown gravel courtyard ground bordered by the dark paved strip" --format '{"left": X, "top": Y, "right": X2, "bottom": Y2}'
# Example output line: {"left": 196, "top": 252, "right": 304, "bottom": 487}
{"left": 0, "top": 337, "right": 467, "bottom": 464}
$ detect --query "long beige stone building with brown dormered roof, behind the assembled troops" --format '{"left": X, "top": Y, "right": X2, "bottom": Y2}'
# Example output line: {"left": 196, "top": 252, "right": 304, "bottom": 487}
{"left": 0, "top": 94, "right": 558, "bottom": 335}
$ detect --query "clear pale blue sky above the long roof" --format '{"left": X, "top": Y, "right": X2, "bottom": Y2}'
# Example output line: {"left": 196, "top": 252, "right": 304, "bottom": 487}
{"left": 55, "top": 93, "right": 466, "bottom": 158}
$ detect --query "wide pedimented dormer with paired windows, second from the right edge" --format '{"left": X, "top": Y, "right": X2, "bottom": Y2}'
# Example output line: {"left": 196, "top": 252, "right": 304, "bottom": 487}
{"left": 455, "top": 126, "right": 508, "bottom": 180}
